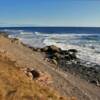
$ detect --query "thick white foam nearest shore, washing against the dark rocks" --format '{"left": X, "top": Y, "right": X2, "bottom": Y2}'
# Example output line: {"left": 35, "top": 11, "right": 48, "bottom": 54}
{"left": 44, "top": 36, "right": 100, "bottom": 65}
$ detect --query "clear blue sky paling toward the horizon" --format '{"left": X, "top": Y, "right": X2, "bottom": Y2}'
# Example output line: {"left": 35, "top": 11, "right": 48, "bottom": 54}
{"left": 0, "top": 0, "right": 100, "bottom": 27}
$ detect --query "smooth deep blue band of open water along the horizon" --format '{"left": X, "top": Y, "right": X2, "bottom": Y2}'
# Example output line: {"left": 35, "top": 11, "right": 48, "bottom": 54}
{"left": 0, "top": 27, "right": 100, "bottom": 34}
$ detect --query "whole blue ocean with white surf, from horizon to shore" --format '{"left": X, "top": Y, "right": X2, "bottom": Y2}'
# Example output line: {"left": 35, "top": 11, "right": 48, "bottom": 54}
{"left": 0, "top": 27, "right": 100, "bottom": 65}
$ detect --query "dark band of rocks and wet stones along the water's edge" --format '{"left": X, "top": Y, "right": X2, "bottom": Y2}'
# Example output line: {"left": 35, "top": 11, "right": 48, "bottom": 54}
{"left": 30, "top": 45, "right": 100, "bottom": 86}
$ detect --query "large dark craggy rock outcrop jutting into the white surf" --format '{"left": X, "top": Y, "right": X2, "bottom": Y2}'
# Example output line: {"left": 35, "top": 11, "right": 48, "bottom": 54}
{"left": 41, "top": 45, "right": 77, "bottom": 66}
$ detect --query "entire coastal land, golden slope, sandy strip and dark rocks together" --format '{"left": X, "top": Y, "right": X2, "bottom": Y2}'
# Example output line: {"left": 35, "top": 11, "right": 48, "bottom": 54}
{"left": 0, "top": 33, "right": 100, "bottom": 100}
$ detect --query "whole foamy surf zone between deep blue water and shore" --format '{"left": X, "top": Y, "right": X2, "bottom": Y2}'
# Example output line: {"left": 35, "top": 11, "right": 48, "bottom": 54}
{"left": 9, "top": 31, "right": 100, "bottom": 65}
